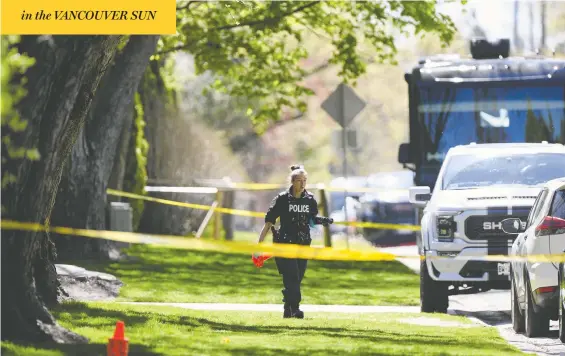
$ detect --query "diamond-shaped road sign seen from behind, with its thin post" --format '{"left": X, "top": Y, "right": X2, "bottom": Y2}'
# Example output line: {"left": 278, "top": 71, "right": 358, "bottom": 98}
{"left": 322, "top": 83, "right": 366, "bottom": 248}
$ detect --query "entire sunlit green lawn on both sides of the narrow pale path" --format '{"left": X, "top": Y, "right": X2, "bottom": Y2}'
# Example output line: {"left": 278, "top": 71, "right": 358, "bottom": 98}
{"left": 2, "top": 232, "right": 522, "bottom": 356}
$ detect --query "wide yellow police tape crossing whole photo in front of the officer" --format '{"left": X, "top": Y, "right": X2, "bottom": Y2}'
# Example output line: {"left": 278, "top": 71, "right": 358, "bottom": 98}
{"left": 0, "top": 220, "right": 565, "bottom": 263}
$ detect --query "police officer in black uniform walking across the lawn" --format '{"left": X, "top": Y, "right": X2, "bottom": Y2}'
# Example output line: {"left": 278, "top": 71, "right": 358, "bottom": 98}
{"left": 258, "top": 165, "right": 333, "bottom": 319}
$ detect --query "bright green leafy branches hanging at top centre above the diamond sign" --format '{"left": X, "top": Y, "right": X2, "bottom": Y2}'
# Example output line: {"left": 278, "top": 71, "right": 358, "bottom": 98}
{"left": 157, "top": 0, "right": 455, "bottom": 129}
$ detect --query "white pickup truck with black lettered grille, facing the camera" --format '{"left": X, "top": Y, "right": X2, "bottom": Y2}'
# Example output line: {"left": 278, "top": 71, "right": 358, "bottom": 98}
{"left": 410, "top": 142, "right": 565, "bottom": 313}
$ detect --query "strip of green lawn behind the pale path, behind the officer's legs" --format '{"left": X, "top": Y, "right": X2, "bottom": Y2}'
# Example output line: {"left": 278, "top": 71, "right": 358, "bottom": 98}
{"left": 66, "top": 245, "right": 419, "bottom": 305}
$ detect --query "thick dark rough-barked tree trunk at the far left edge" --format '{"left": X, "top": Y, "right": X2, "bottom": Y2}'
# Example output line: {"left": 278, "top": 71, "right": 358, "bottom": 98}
{"left": 2, "top": 36, "right": 119, "bottom": 342}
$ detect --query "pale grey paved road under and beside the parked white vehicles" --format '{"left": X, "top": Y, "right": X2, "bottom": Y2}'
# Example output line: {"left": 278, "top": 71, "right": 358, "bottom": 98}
{"left": 376, "top": 246, "right": 565, "bottom": 356}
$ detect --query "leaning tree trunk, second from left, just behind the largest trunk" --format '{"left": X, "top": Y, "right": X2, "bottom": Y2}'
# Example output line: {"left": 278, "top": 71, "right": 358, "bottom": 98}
{"left": 52, "top": 36, "right": 159, "bottom": 259}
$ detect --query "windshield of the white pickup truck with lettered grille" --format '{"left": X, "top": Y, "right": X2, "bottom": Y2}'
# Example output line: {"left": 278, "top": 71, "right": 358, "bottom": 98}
{"left": 442, "top": 152, "right": 565, "bottom": 190}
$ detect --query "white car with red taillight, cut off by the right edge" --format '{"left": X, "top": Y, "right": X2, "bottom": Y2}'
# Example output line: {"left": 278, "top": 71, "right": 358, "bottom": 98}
{"left": 503, "top": 177, "right": 565, "bottom": 337}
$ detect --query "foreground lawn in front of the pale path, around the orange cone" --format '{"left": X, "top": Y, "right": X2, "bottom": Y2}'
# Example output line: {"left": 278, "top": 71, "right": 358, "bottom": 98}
{"left": 2, "top": 303, "right": 522, "bottom": 356}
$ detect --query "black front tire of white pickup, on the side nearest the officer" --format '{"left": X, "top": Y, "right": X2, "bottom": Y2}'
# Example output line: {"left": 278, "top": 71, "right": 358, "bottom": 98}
{"left": 420, "top": 260, "right": 449, "bottom": 313}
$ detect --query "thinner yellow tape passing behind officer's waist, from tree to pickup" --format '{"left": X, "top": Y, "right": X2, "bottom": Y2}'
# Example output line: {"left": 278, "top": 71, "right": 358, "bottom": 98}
{"left": 106, "top": 189, "right": 420, "bottom": 231}
